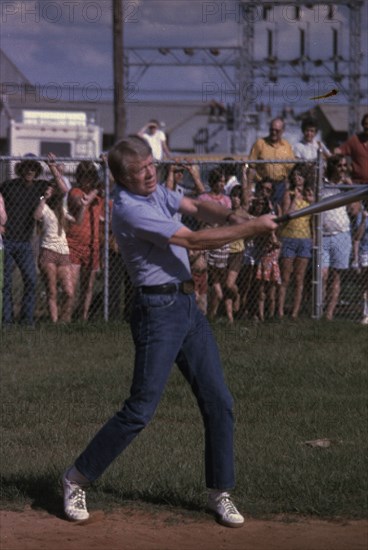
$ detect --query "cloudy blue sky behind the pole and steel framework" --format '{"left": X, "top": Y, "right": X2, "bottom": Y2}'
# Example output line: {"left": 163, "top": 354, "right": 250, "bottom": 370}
{"left": 0, "top": 0, "right": 368, "bottom": 113}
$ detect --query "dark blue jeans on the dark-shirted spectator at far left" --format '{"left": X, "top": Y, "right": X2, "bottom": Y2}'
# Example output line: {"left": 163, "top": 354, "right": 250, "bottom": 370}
{"left": 3, "top": 239, "right": 37, "bottom": 324}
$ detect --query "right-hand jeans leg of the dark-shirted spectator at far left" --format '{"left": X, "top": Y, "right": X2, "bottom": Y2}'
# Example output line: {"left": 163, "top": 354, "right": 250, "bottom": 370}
{"left": 15, "top": 242, "right": 37, "bottom": 324}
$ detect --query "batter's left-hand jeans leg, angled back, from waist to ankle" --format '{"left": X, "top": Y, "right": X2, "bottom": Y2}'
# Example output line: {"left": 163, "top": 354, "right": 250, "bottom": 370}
{"left": 75, "top": 293, "right": 190, "bottom": 481}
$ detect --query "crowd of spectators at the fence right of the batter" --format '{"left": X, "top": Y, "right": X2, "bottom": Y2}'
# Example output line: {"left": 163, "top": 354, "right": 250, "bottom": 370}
{"left": 166, "top": 115, "right": 368, "bottom": 324}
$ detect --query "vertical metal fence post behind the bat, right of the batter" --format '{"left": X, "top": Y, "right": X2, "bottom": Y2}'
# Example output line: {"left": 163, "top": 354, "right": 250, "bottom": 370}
{"left": 312, "top": 148, "right": 323, "bottom": 320}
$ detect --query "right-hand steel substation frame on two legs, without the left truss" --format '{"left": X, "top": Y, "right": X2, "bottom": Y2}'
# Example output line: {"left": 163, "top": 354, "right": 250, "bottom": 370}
{"left": 234, "top": 0, "right": 363, "bottom": 152}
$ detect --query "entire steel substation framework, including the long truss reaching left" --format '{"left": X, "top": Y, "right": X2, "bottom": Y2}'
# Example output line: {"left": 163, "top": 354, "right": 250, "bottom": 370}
{"left": 125, "top": 0, "right": 367, "bottom": 153}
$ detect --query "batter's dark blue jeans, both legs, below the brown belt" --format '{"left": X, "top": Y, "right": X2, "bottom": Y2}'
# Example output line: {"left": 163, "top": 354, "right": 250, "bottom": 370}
{"left": 75, "top": 290, "right": 235, "bottom": 490}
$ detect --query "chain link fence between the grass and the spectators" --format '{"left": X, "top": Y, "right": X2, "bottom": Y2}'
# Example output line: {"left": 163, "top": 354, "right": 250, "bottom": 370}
{"left": 0, "top": 156, "right": 368, "bottom": 325}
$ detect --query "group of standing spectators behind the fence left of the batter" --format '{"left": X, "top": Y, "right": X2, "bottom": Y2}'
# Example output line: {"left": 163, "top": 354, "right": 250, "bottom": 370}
{"left": 0, "top": 153, "right": 103, "bottom": 326}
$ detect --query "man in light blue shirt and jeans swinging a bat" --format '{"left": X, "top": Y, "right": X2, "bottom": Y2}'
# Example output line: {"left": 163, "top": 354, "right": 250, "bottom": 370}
{"left": 63, "top": 136, "right": 277, "bottom": 527}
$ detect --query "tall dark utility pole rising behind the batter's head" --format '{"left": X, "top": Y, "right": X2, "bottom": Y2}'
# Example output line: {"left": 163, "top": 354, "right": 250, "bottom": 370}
{"left": 112, "top": 0, "right": 126, "bottom": 141}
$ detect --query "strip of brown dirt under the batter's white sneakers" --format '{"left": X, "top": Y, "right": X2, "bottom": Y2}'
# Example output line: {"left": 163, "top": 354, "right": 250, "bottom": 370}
{"left": 0, "top": 508, "right": 368, "bottom": 550}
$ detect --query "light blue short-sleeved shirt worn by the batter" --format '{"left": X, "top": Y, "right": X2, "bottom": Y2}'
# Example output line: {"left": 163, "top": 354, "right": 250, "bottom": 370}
{"left": 112, "top": 185, "right": 191, "bottom": 286}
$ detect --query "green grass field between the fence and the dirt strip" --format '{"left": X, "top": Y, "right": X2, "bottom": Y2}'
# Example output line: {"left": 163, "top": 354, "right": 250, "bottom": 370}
{"left": 0, "top": 320, "right": 368, "bottom": 518}
